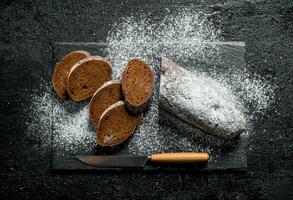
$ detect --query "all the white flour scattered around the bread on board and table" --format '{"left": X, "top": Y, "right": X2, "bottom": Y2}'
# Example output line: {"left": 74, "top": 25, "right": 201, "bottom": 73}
{"left": 26, "top": 9, "right": 274, "bottom": 154}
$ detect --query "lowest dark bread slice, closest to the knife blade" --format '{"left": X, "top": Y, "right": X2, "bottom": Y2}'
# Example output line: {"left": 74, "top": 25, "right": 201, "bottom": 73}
{"left": 97, "top": 101, "right": 142, "bottom": 147}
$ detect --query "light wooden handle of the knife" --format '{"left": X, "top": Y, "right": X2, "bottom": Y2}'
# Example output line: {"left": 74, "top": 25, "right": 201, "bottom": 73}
{"left": 149, "top": 152, "right": 209, "bottom": 164}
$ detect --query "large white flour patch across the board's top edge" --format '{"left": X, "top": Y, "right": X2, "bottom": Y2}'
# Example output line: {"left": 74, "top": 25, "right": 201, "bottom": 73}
{"left": 106, "top": 8, "right": 221, "bottom": 77}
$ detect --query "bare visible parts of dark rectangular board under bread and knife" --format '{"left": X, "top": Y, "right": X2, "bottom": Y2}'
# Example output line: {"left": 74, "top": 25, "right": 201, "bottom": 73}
{"left": 52, "top": 42, "right": 247, "bottom": 171}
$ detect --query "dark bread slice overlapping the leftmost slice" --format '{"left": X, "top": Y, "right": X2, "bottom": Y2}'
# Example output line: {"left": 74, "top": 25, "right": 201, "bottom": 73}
{"left": 67, "top": 56, "right": 112, "bottom": 101}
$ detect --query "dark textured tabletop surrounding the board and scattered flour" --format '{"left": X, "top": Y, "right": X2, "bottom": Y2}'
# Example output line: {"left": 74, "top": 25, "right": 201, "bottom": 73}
{"left": 0, "top": 0, "right": 293, "bottom": 199}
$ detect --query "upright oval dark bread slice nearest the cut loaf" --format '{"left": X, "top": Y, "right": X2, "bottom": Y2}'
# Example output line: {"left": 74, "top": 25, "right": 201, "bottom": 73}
{"left": 121, "top": 59, "right": 154, "bottom": 114}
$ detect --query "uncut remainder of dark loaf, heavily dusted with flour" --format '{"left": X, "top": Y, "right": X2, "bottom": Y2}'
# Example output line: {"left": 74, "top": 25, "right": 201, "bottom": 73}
{"left": 159, "top": 57, "right": 246, "bottom": 139}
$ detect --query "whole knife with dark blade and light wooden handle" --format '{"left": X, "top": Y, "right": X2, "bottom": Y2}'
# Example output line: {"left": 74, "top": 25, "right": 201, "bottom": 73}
{"left": 76, "top": 152, "right": 209, "bottom": 168}
